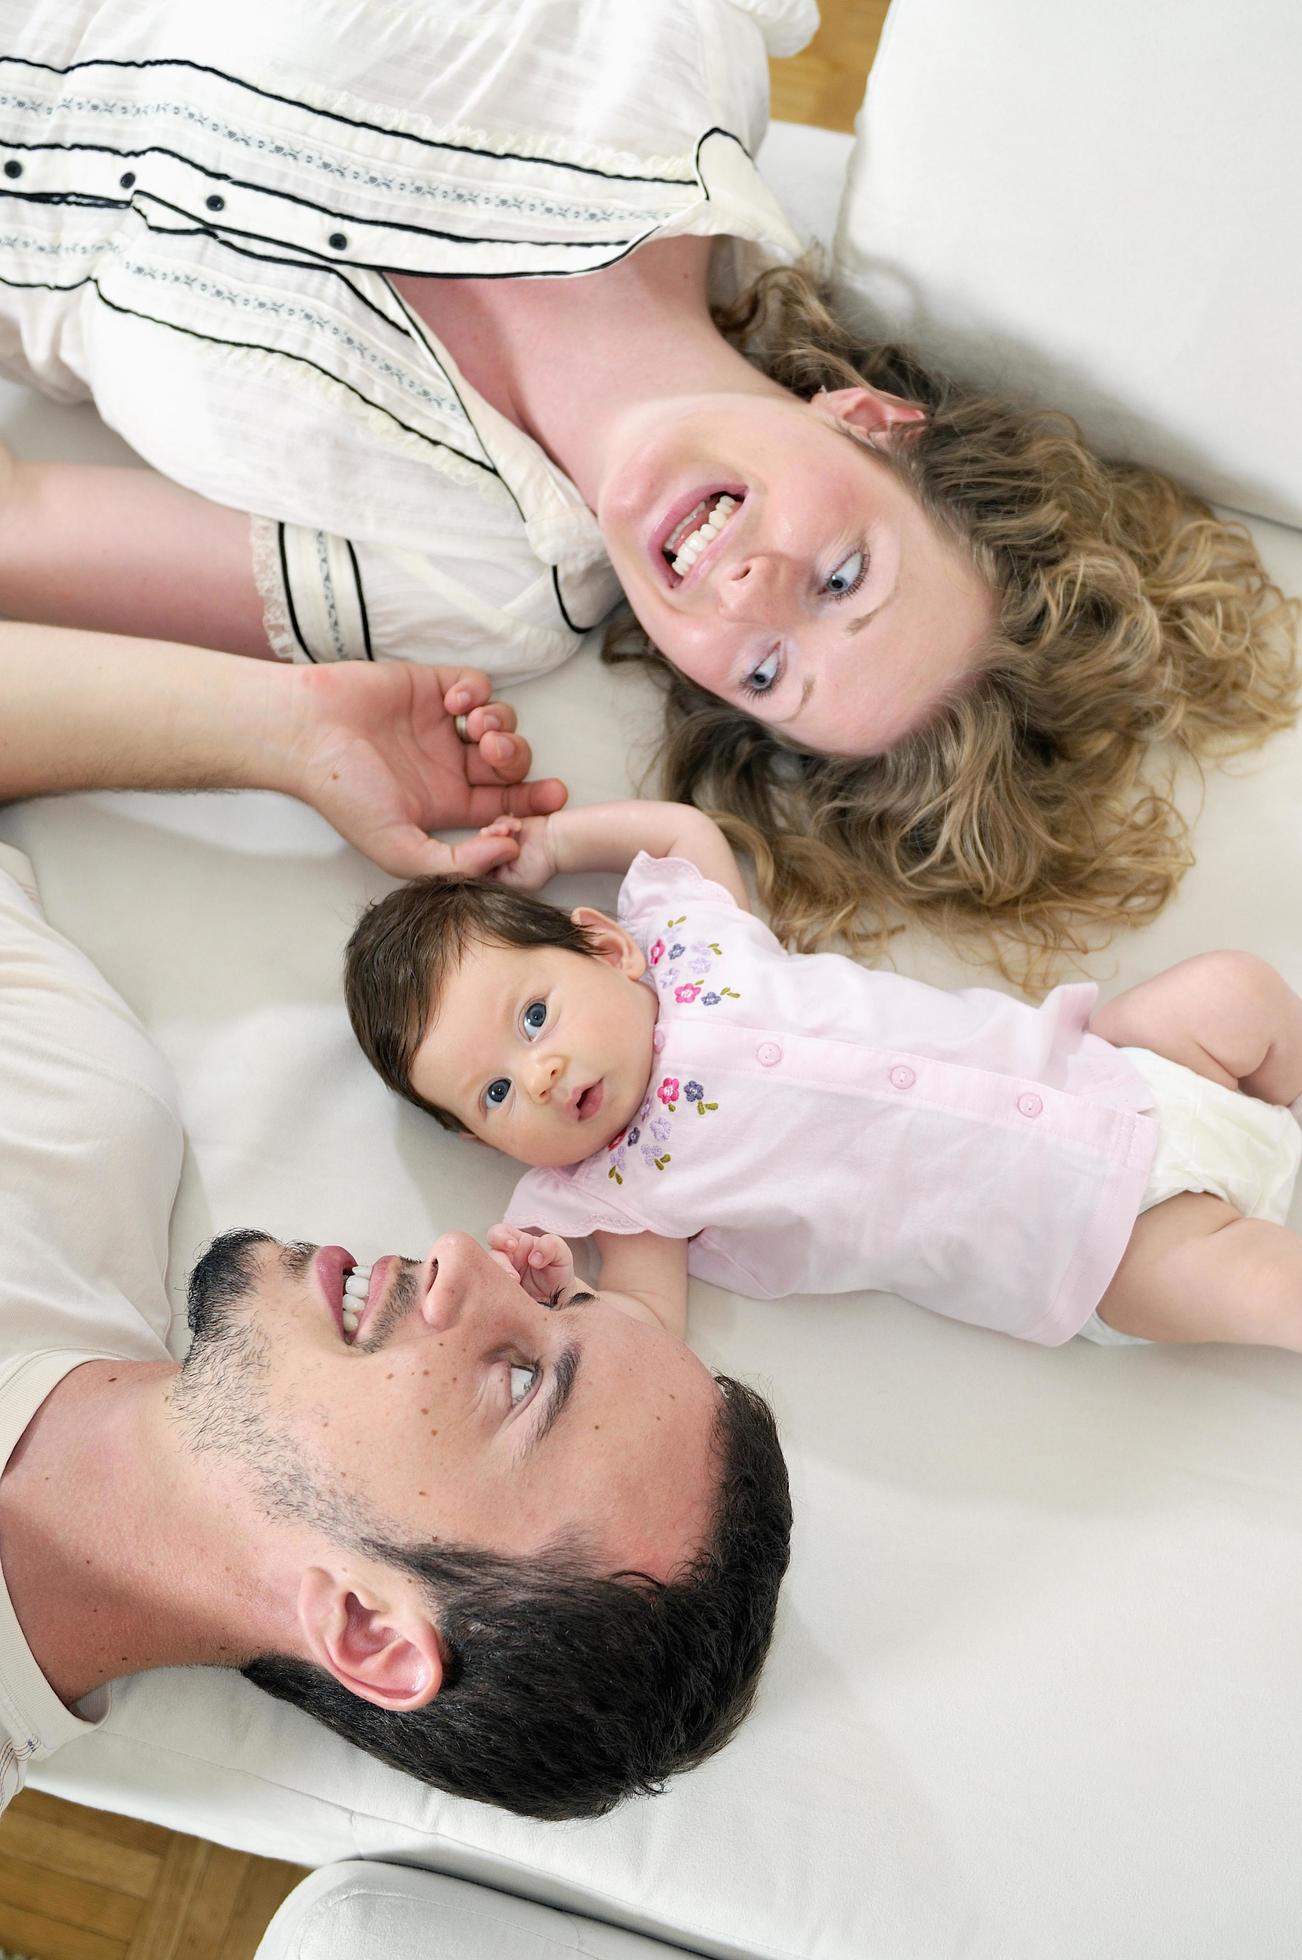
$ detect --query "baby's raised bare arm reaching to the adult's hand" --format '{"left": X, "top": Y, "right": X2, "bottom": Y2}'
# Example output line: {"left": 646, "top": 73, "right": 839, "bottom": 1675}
{"left": 486, "top": 802, "right": 751, "bottom": 911}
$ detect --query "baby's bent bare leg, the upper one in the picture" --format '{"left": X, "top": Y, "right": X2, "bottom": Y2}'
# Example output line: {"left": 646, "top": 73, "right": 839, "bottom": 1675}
{"left": 1090, "top": 953, "right": 1302, "bottom": 1103}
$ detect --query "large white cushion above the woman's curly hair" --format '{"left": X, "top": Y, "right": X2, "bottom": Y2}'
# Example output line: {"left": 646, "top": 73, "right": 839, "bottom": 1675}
{"left": 835, "top": 0, "right": 1302, "bottom": 523}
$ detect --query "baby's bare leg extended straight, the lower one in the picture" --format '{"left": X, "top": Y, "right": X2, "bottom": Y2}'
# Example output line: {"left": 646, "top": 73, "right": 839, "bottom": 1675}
{"left": 1098, "top": 1192, "right": 1302, "bottom": 1352}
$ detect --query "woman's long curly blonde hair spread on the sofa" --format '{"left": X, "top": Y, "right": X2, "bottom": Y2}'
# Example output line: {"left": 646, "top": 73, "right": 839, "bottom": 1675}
{"left": 606, "top": 263, "right": 1296, "bottom": 984}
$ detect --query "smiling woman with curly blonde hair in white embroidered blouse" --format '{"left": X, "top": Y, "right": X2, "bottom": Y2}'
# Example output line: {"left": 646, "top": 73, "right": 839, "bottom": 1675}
{"left": 0, "top": 0, "right": 1294, "bottom": 970}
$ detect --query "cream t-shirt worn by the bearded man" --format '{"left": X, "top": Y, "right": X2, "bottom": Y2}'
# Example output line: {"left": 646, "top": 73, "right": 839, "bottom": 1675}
{"left": 0, "top": 845, "right": 180, "bottom": 1809}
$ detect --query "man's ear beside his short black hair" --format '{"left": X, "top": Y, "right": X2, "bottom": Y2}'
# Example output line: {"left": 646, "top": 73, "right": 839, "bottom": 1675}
{"left": 298, "top": 1566, "right": 443, "bottom": 1713}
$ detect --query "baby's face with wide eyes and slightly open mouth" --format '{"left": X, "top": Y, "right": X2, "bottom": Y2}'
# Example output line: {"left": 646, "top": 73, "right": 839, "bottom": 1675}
{"left": 412, "top": 927, "right": 657, "bottom": 1166}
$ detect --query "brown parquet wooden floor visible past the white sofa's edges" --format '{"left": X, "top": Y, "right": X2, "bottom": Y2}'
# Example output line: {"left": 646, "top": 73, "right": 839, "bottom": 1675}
{"left": 0, "top": 0, "right": 886, "bottom": 1960}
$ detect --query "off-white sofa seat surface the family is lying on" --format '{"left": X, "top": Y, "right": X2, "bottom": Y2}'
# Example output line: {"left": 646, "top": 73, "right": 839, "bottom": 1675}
{"left": 0, "top": 118, "right": 1302, "bottom": 1960}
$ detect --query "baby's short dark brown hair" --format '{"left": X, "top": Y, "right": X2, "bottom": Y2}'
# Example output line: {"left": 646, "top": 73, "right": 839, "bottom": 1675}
{"left": 343, "top": 878, "right": 596, "bottom": 1133}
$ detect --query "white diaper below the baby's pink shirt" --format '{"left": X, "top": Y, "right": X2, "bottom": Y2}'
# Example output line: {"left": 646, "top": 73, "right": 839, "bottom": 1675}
{"left": 1080, "top": 1049, "right": 1302, "bottom": 1347}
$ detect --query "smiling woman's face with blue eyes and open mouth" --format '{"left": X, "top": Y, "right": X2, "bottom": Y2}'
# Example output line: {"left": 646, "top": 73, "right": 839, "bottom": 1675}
{"left": 596, "top": 388, "right": 994, "bottom": 755}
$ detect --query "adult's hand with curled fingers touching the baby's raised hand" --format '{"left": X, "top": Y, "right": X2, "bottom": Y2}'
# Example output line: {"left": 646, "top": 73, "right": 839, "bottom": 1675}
{"left": 280, "top": 661, "right": 567, "bottom": 878}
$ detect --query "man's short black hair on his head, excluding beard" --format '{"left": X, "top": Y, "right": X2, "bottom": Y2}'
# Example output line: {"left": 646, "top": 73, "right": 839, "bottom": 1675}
{"left": 243, "top": 1376, "right": 790, "bottom": 1819}
